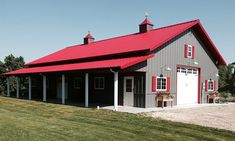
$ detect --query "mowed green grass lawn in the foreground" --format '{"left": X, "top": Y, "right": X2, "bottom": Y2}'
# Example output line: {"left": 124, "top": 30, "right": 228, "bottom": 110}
{"left": 0, "top": 96, "right": 235, "bottom": 141}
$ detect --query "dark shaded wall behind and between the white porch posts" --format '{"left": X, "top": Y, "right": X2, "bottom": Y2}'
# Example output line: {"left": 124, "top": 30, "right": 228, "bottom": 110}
{"left": 5, "top": 71, "right": 145, "bottom": 107}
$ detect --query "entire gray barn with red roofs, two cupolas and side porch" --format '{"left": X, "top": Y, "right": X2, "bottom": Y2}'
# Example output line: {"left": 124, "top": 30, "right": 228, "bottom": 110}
{"left": 4, "top": 18, "right": 226, "bottom": 110}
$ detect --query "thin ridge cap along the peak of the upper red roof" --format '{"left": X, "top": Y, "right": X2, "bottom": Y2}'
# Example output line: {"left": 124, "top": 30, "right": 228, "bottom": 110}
{"left": 64, "top": 19, "right": 200, "bottom": 49}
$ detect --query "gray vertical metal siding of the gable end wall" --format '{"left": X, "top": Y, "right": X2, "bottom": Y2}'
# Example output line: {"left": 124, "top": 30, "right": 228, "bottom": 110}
{"left": 145, "top": 30, "right": 218, "bottom": 107}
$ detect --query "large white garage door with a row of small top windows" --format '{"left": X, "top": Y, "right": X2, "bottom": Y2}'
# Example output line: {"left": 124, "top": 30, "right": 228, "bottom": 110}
{"left": 177, "top": 67, "right": 198, "bottom": 105}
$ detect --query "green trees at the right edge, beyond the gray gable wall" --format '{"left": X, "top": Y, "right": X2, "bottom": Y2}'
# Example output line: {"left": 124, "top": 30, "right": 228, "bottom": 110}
{"left": 219, "top": 64, "right": 235, "bottom": 95}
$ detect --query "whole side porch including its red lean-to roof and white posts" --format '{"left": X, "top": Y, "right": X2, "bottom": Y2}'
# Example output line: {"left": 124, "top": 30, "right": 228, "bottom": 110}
{"left": 5, "top": 56, "right": 151, "bottom": 110}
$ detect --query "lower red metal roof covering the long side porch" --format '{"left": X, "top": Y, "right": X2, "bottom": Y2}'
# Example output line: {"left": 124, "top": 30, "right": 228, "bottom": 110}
{"left": 5, "top": 55, "right": 154, "bottom": 75}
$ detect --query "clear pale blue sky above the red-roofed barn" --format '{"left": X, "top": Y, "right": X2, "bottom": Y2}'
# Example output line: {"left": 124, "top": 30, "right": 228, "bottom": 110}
{"left": 0, "top": 0, "right": 235, "bottom": 63}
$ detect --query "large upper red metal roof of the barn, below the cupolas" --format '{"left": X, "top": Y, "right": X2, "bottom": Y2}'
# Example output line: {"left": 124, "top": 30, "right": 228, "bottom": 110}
{"left": 26, "top": 20, "right": 226, "bottom": 66}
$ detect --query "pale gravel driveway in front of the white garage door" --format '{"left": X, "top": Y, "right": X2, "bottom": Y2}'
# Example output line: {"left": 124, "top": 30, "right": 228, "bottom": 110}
{"left": 147, "top": 103, "right": 235, "bottom": 131}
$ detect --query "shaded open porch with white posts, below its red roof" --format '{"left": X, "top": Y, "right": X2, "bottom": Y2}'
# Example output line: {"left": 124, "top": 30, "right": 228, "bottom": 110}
{"left": 7, "top": 70, "right": 145, "bottom": 110}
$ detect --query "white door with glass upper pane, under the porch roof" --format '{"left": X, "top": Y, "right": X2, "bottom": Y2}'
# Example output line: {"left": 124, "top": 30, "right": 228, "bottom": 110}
{"left": 123, "top": 76, "right": 134, "bottom": 106}
